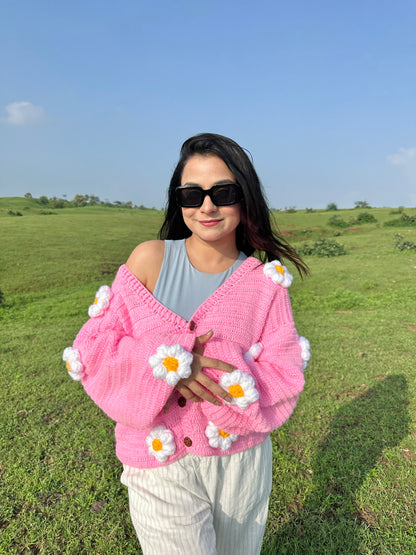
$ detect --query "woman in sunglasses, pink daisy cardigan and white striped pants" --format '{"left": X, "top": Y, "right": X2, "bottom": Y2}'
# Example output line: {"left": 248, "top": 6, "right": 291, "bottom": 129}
{"left": 64, "top": 133, "right": 309, "bottom": 555}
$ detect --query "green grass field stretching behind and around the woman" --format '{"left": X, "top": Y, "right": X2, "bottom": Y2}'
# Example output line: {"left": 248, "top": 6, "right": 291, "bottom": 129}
{"left": 0, "top": 198, "right": 416, "bottom": 555}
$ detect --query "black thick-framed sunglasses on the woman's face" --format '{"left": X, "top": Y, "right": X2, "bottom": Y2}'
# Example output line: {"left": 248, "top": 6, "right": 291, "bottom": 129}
{"left": 175, "top": 183, "right": 243, "bottom": 208}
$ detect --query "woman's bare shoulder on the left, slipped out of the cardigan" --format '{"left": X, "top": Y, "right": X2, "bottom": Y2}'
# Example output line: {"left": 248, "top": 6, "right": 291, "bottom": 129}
{"left": 126, "top": 240, "right": 165, "bottom": 293}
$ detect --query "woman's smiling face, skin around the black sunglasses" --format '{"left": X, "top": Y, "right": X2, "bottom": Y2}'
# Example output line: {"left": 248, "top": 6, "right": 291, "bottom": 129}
{"left": 181, "top": 154, "right": 240, "bottom": 245}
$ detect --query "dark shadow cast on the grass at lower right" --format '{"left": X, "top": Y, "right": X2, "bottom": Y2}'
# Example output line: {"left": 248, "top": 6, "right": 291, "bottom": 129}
{"left": 262, "top": 375, "right": 410, "bottom": 555}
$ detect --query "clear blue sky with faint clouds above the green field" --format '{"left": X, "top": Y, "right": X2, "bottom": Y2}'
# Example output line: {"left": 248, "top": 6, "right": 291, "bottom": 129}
{"left": 0, "top": 0, "right": 416, "bottom": 208}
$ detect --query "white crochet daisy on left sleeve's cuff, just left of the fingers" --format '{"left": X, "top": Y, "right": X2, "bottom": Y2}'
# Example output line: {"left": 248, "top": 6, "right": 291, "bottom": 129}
{"left": 149, "top": 344, "right": 193, "bottom": 386}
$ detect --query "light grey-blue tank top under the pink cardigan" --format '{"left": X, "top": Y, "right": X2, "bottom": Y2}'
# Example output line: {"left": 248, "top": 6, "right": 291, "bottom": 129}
{"left": 153, "top": 239, "right": 247, "bottom": 320}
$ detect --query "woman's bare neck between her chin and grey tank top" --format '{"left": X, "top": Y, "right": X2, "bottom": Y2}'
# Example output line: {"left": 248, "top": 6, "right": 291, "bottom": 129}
{"left": 185, "top": 235, "right": 239, "bottom": 274}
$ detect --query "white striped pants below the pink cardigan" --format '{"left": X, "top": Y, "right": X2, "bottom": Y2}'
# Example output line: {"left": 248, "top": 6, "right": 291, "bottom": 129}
{"left": 121, "top": 438, "right": 272, "bottom": 555}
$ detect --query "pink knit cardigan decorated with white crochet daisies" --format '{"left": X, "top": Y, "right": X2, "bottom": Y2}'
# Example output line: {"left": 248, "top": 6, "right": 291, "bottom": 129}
{"left": 64, "top": 257, "right": 305, "bottom": 468}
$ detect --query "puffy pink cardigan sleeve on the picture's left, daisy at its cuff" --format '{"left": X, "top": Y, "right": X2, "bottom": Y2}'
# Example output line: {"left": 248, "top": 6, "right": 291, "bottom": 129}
{"left": 64, "top": 293, "right": 195, "bottom": 429}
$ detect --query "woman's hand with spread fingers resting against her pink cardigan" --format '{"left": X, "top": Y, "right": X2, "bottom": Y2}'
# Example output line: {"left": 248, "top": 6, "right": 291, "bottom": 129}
{"left": 175, "top": 330, "right": 235, "bottom": 405}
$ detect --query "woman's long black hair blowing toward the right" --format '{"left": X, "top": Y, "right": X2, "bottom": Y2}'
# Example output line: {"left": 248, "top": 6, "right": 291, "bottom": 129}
{"left": 159, "top": 133, "right": 309, "bottom": 276}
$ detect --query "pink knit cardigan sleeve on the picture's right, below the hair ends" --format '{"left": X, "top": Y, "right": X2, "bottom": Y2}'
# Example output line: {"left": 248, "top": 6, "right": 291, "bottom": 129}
{"left": 201, "top": 286, "right": 304, "bottom": 435}
